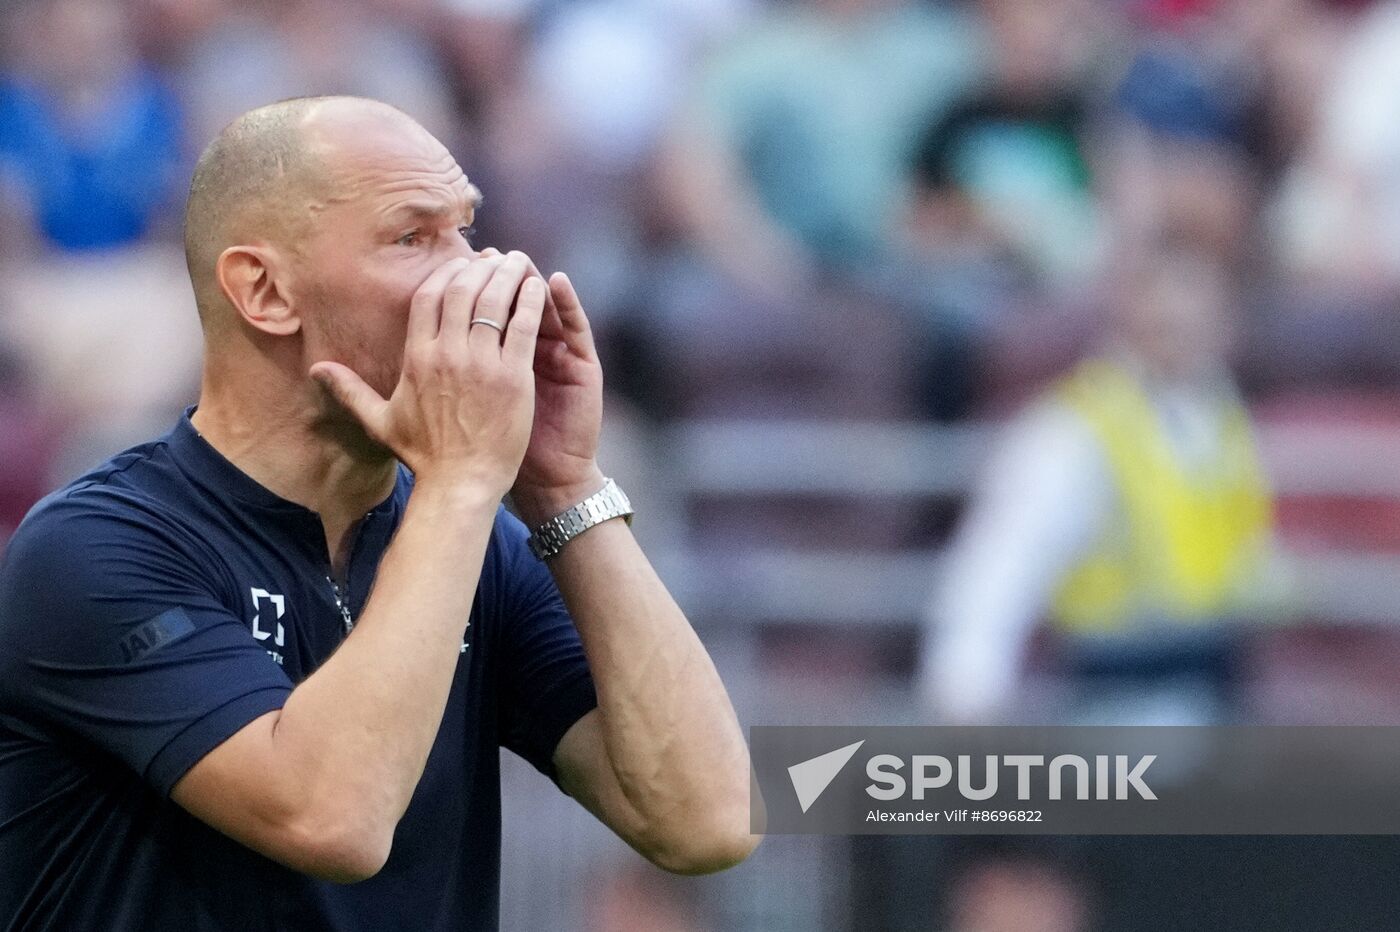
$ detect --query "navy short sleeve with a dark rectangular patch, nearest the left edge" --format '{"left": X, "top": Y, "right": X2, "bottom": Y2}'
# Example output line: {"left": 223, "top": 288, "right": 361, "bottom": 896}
{"left": 0, "top": 500, "right": 293, "bottom": 795}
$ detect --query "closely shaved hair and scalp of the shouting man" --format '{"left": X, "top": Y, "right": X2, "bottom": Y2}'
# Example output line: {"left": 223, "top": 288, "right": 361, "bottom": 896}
{"left": 185, "top": 97, "right": 424, "bottom": 332}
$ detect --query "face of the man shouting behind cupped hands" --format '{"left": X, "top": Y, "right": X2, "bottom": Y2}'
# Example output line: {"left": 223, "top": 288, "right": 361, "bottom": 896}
{"left": 290, "top": 113, "right": 479, "bottom": 397}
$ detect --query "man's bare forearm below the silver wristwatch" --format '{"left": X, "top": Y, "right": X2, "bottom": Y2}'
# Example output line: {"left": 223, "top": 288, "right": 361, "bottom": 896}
{"left": 550, "top": 521, "right": 752, "bottom": 869}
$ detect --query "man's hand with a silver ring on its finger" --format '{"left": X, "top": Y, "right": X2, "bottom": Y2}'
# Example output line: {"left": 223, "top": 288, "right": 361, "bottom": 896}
{"left": 311, "top": 252, "right": 546, "bottom": 497}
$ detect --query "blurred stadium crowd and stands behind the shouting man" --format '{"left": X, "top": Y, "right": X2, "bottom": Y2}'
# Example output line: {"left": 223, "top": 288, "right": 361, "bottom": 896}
{"left": 0, "top": 0, "right": 1400, "bottom": 932}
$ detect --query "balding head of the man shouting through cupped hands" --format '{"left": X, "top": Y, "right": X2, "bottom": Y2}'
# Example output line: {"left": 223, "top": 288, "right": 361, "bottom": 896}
{"left": 185, "top": 97, "right": 480, "bottom": 399}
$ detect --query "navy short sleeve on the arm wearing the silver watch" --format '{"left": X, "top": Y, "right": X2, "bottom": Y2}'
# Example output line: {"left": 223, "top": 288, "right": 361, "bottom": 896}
{"left": 494, "top": 512, "right": 598, "bottom": 784}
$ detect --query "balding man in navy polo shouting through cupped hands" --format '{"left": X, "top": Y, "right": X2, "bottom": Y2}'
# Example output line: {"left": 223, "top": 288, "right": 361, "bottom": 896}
{"left": 0, "top": 98, "right": 756, "bottom": 931}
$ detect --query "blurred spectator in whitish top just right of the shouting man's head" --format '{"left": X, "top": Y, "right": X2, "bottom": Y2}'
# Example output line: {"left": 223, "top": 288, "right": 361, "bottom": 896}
{"left": 498, "top": 0, "right": 750, "bottom": 330}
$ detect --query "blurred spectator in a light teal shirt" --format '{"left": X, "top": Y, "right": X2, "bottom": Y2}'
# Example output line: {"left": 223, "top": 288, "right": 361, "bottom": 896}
{"left": 665, "top": 0, "right": 981, "bottom": 295}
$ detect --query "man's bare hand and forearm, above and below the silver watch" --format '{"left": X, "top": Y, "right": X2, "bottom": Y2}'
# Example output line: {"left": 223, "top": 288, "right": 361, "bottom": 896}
{"left": 439, "top": 249, "right": 757, "bottom": 873}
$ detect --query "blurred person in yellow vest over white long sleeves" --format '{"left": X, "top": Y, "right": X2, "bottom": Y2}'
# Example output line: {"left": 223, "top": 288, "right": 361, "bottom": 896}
{"left": 921, "top": 244, "right": 1271, "bottom": 722}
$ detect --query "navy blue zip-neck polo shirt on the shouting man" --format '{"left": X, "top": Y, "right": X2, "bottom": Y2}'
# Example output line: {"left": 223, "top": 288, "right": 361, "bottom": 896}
{"left": 0, "top": 413, "right": 596, "bottom": 932}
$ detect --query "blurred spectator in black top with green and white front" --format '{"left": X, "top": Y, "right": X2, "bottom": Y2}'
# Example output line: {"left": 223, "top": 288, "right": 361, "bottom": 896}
{"left": 884, "top": 0, "right": 1110, "bottom": 420}
